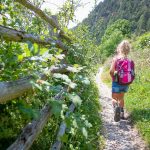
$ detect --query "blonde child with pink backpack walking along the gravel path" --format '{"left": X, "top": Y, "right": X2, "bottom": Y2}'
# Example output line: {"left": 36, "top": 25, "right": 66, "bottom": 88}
{"left": 110, "top": 40, "right": 134, "bottom": 122}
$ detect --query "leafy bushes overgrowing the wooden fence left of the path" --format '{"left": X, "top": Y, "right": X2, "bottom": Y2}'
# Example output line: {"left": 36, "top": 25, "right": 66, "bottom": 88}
{"left": 0, "top": 0, "right": 103, "bottom": 150}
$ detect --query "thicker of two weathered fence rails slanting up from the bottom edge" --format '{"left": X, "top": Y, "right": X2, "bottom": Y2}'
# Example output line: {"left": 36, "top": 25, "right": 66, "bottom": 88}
{"left": 7, "top": 89, "right": 66, "bottom": 150}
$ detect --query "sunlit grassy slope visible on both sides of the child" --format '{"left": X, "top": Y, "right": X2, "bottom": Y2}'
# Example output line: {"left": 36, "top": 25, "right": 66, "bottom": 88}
{"left": 102, "top": 32, "right": 150, "bottom": 147}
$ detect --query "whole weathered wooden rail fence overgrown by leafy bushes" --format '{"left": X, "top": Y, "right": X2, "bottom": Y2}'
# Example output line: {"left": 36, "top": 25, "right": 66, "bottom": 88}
{"left": 0, "top": 0, "right": 78, "bottom": 150}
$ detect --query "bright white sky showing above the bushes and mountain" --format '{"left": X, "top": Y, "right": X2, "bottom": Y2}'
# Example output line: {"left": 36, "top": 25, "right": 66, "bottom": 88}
{"left": 42, "top": 0, "right": 103, "bottom": 28}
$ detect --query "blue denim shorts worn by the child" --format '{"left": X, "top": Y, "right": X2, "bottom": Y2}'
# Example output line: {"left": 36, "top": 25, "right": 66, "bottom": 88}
{"left": 112, "top": 82, "right": 129, "bottom": 93}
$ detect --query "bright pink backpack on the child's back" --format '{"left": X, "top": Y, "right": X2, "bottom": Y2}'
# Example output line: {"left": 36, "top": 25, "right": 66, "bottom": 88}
{"left": 115, "top": 58, "right": 135, "bottom": 85}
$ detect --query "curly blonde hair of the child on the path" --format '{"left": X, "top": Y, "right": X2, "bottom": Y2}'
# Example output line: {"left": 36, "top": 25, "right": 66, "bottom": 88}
{"left": 116, "top": 40, "right": 131, "bottom": 56}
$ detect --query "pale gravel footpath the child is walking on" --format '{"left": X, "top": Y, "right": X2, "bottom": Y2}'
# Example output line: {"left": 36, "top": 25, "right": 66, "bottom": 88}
{"left": 96, "top": 68, "right": 148, "bottom": 150}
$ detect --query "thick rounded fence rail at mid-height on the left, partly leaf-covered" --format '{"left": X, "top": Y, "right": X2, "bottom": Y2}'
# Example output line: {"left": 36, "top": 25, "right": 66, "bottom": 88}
{"left": 0, "top": 64, "right": 69, "bottom": 104}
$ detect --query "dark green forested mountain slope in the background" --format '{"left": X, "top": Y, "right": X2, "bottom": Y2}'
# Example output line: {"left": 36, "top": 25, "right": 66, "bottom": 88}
{"left": 83, "top": 0, "right": 150, "bottom": 42}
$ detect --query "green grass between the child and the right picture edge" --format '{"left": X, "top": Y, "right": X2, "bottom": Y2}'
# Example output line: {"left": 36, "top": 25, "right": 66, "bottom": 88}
{"left": 126, "top": 49, "right": 150, "bottom": 148}
